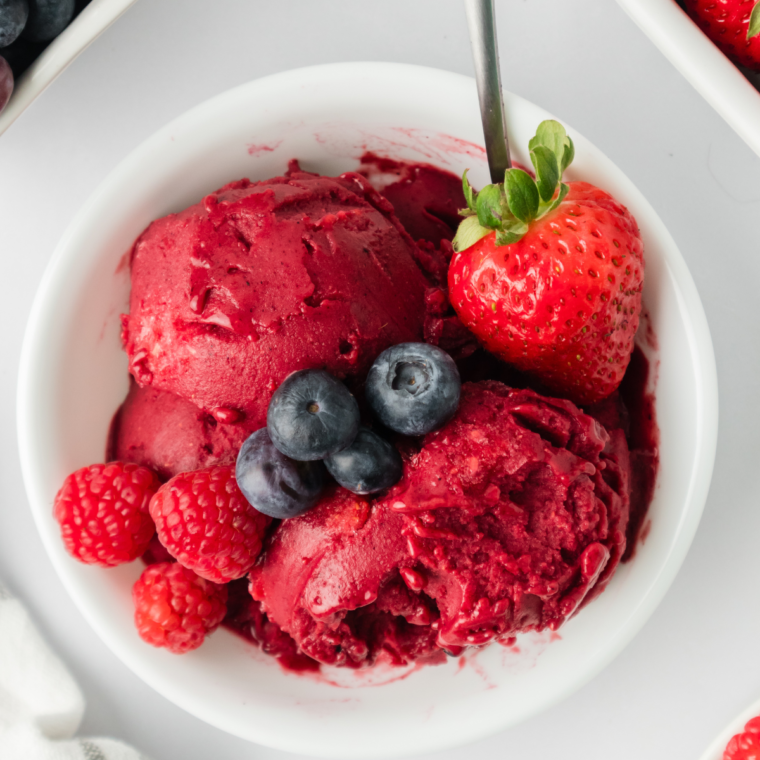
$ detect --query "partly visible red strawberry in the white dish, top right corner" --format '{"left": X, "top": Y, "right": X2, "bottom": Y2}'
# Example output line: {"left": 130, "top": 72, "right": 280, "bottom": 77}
{"left": 685, "top": 0, "right": 760, "bottom": 71}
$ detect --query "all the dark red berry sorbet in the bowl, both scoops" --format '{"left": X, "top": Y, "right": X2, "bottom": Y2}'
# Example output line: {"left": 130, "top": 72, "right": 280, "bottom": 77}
{"left": 102, "top": 155, "right": 657, "bottom": 669}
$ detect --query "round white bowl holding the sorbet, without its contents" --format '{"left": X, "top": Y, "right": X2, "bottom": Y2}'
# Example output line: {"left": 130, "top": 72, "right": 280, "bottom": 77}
{"left": 18, "top": 63, "right": 717, "bottom": 758}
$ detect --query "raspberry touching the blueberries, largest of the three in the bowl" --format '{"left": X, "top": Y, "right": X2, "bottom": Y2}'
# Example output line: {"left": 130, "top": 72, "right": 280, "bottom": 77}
{"left": 150, "top": 465, "right": 270, "bottom": 583}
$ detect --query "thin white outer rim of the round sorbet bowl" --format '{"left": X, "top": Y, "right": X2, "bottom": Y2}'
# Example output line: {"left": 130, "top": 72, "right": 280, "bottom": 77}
{"left": 17, "top": 62, "right": 718, "bottom": 757}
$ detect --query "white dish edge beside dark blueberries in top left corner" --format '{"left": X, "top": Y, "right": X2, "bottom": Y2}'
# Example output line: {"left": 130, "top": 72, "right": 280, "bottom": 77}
{"left": 0, "top": 0, "right": 135, "bottom": 135}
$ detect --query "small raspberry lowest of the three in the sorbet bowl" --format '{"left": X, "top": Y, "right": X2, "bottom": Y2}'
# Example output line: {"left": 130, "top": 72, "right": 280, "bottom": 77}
{"left": 132, "top": 562, "right": 227, "bottom": 654}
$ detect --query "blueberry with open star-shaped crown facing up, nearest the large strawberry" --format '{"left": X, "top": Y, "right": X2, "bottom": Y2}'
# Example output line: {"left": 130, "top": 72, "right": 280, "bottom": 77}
{"left": 366, "top": 343, "right": 462, "bottom": 435}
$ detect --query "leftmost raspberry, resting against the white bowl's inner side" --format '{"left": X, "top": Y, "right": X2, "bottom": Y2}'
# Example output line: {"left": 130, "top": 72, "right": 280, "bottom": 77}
{"left": 53, "top": 462, "right": 160, "bottom": 567}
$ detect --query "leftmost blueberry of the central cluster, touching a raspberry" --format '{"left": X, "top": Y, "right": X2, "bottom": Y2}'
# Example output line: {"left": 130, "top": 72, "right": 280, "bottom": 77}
{"left": 235, "top": 428, "right": 324, "bottom": 520}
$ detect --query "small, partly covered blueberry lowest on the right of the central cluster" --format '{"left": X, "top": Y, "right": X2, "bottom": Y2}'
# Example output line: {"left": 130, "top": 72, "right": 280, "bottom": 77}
{"left": 325, "top": 426, "right": 403, "bottom": 493}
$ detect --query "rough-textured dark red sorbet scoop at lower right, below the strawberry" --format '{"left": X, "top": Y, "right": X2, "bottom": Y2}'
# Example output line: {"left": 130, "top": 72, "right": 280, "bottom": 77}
{"left": 251, "top": 381, "right": 630, "bottom": 667}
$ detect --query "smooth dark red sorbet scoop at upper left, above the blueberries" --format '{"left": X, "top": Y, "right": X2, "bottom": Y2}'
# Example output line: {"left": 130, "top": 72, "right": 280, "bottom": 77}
{"left": 123, "top": 169, "right": 441, "bottom": 428}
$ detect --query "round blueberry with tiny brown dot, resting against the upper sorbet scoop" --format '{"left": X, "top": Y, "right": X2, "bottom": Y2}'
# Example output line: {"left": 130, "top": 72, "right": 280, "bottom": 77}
{"left": 267, "top": 369, "right": 359, "bottom": 462}
